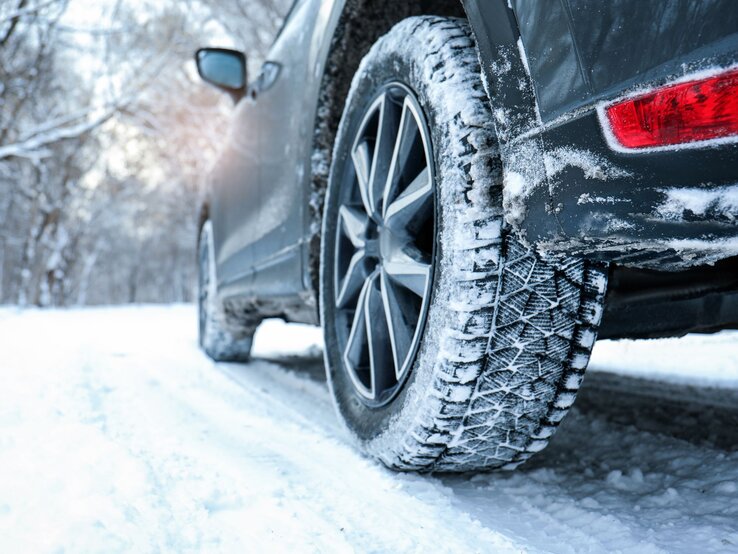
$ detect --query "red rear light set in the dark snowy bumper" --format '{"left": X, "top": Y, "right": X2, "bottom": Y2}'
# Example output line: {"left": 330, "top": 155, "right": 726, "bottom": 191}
{"left": 605, "top": 70, "right": 738, "bottom": 148}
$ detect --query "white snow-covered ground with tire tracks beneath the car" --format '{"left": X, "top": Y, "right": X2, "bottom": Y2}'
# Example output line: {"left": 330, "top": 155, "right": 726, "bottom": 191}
{"left": 0, "top": 306, "right": 738, "bottom": 553}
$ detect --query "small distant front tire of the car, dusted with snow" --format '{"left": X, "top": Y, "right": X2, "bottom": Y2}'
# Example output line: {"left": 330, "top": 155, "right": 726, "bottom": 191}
{"left": 197, "top": 221, "right": 253, "bottom": 362}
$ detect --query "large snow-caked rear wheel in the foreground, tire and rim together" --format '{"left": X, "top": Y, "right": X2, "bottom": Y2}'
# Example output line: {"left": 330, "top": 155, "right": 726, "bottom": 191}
{"left": 320, "top": 17, "right": 606, "bottom": 471}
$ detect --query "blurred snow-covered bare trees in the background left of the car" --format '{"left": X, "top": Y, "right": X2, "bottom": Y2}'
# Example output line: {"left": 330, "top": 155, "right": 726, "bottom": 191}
{"left": 0, "top": 0, "right": 289, "bottom": 306}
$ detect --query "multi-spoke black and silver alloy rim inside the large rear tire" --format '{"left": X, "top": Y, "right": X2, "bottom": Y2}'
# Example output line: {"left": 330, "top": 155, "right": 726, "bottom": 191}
{"left": 334, "top": 83, "right": 436, "bottom": 406}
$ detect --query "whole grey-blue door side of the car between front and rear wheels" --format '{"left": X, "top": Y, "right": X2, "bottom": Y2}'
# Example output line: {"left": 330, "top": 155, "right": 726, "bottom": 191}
{"left": 211, "top": 0, "right": 337, "bottom": 298}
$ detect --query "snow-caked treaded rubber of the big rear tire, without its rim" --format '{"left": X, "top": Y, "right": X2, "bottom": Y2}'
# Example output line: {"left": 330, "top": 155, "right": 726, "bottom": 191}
{"left": 321, "top": 17, "right": 606, "bottom": 471}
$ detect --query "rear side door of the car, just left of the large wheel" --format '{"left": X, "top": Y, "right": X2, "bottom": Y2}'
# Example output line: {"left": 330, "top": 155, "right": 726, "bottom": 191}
{"left": 247, "top": 0, "right": 324, "bottom": 296}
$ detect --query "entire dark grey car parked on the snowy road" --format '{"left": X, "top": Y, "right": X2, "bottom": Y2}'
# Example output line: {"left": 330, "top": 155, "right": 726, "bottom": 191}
{"left": 196, "top": 0, "right": 738, "bottom": 471}
